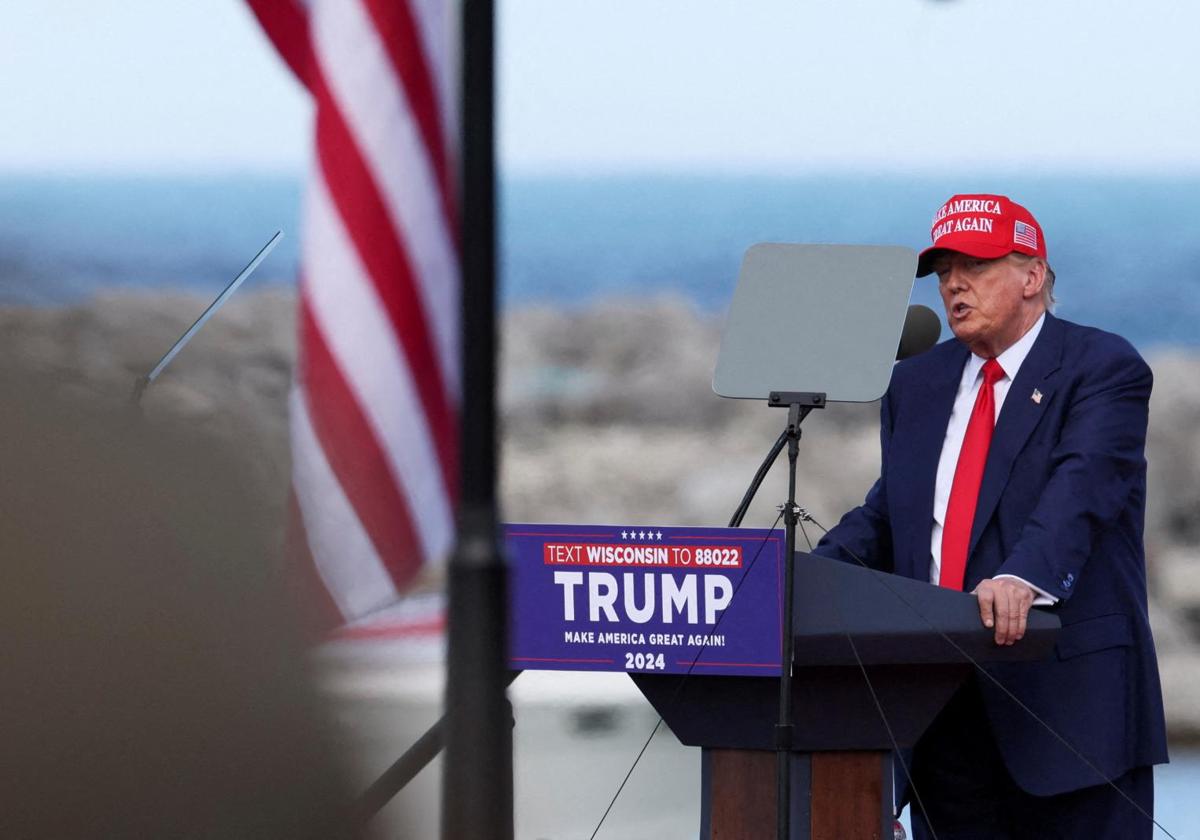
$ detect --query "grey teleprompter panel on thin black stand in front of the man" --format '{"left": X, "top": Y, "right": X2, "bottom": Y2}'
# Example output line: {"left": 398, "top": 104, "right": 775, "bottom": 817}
{"left": 710, "top": 244, "right": 916, "bottom": 840}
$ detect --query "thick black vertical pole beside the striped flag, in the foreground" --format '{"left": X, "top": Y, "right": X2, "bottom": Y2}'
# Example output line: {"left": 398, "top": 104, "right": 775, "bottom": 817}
{"left": 442, "top": 0, "right": 512, "bottom": 840}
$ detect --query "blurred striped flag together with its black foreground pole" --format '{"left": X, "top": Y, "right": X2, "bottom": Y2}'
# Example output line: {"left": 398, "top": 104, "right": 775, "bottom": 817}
{"left": 247, "top": 0, "right": 512, "bottom": 840}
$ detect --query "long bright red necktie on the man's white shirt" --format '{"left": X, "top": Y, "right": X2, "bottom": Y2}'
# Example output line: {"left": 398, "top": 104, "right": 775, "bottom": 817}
{"left": 937, "top": 359, "right": 1004, "bottom": 590}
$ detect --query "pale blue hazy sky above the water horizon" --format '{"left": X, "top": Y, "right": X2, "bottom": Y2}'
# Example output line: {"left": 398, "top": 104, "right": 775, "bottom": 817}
{"left": 0, "top": 0, "right": 1200, "bottom": 174}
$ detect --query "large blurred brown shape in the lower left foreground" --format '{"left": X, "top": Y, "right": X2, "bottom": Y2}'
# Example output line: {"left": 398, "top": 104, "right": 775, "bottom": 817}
{"left": 0, "top": 372, "right": 348, "bottom": 838}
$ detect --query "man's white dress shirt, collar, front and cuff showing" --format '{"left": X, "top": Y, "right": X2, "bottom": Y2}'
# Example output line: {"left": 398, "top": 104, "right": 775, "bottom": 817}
{"left": 929, "top": 314, "right": 1058, "bottom": 606}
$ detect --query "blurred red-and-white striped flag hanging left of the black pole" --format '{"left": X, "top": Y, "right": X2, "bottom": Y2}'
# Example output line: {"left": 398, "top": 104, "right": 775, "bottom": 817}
{"left": 247, "top": 0, "right": 461, "bottom": 622}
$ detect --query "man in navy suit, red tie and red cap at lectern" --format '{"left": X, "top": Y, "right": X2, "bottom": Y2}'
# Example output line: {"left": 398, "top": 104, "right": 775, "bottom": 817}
{"left": 817, "top": 194, "right": 1166, "bottom": 840}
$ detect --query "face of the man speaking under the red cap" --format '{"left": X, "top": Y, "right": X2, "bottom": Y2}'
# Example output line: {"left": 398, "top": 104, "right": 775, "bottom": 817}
{"left": 934, "top": 251, "right": 1045, "bottom": 358}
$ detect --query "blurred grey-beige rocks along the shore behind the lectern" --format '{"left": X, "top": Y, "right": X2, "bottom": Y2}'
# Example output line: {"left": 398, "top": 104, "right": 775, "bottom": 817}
{"left": 0, "top": 290, "right": 1200, "bottom": 742}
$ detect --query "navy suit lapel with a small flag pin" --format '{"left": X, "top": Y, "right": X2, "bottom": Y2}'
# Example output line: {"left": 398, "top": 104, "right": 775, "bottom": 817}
{"left": 967, "top": 312, "right": 1063, "bottom": 563}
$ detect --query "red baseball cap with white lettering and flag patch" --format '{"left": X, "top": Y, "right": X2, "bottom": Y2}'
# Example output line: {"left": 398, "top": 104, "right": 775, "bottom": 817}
{"left": 917, "top": 193, "right": 1046, "bottom": 277}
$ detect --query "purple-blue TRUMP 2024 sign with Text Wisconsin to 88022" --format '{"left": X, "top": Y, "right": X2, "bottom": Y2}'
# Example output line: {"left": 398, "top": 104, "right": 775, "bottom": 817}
{"left": 504, "top": 524, "right": 785, "bottom": 677}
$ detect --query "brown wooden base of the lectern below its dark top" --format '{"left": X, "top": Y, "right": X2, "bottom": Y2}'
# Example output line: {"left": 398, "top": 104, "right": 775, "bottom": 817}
{"left": 700, "top": 748, "right": 892, "bottom": 840}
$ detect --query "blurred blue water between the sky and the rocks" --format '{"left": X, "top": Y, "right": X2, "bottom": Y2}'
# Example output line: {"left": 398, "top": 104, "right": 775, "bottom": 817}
{"left": 0, "top": 175, "right": 1200, "bottom": 349}
